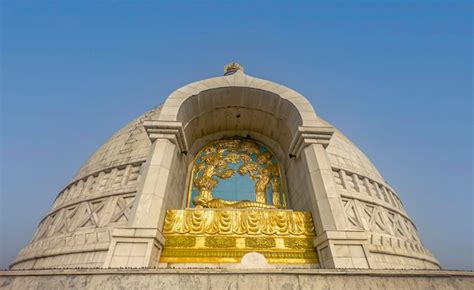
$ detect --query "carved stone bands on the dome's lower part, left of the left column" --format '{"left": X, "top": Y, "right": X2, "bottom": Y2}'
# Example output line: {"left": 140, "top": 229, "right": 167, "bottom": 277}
{"left": 11, "top": 192, "right": 136, "bottom": 268}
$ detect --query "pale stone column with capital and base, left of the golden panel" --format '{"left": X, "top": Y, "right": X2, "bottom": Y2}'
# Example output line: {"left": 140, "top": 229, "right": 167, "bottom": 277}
{"left": 104, "top": 121, "right": 187, "bottom": 268}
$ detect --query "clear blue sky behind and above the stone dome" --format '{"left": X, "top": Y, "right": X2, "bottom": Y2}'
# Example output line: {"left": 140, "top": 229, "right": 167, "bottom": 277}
{"left": 0, "top": 1, "right": 474, "bottom": 269}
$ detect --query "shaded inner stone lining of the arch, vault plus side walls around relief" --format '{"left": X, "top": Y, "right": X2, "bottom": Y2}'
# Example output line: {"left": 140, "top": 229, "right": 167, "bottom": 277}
{"left": 164, "top": 87, "right": 315, "bottom": 210}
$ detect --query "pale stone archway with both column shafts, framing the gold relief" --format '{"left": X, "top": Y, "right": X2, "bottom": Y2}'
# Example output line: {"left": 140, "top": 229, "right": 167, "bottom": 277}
{"left": 126, "top": 71, "right": 344, "bottom": 268}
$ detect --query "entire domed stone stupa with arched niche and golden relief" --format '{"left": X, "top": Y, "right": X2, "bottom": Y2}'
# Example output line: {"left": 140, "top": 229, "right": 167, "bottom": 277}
{"left": 4, "top": 62, "right": 472, "bottom": 289}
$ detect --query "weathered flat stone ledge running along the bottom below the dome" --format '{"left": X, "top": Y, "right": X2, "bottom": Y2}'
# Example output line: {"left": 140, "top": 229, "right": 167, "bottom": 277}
{"left": 0, "top": 269, "right": 474, "bottom": 290}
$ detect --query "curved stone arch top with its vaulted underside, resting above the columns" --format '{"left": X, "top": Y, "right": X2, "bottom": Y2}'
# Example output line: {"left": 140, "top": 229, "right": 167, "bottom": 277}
{"left": 159, "top": 71, "right": 319, "bottom": 150}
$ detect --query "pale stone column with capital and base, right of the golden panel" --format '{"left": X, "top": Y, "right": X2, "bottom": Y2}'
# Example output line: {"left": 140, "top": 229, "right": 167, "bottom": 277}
{"left": 290, "top": 127, "right": 369, "bottom": 268}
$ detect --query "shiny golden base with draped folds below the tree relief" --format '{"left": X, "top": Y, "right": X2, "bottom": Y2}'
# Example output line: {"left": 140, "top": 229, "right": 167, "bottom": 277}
{"left": 160, "top": 209, "right": 319, "bottom": 264}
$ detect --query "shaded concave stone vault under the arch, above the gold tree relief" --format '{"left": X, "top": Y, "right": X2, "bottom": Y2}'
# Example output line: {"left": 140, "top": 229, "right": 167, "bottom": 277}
{"left": 177, "top": 87, "right": 302, "bottom": 159}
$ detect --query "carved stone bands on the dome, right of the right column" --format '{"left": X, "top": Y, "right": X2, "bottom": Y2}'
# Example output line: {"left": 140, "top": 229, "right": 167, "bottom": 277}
{"left": 328, "top": 168, "right": 440, "bottom": 269}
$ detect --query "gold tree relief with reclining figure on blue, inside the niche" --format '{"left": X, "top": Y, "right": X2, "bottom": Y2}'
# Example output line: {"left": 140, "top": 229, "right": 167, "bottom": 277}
{"left": 192, "top": 137, "right": 283, "bottom": 208}
